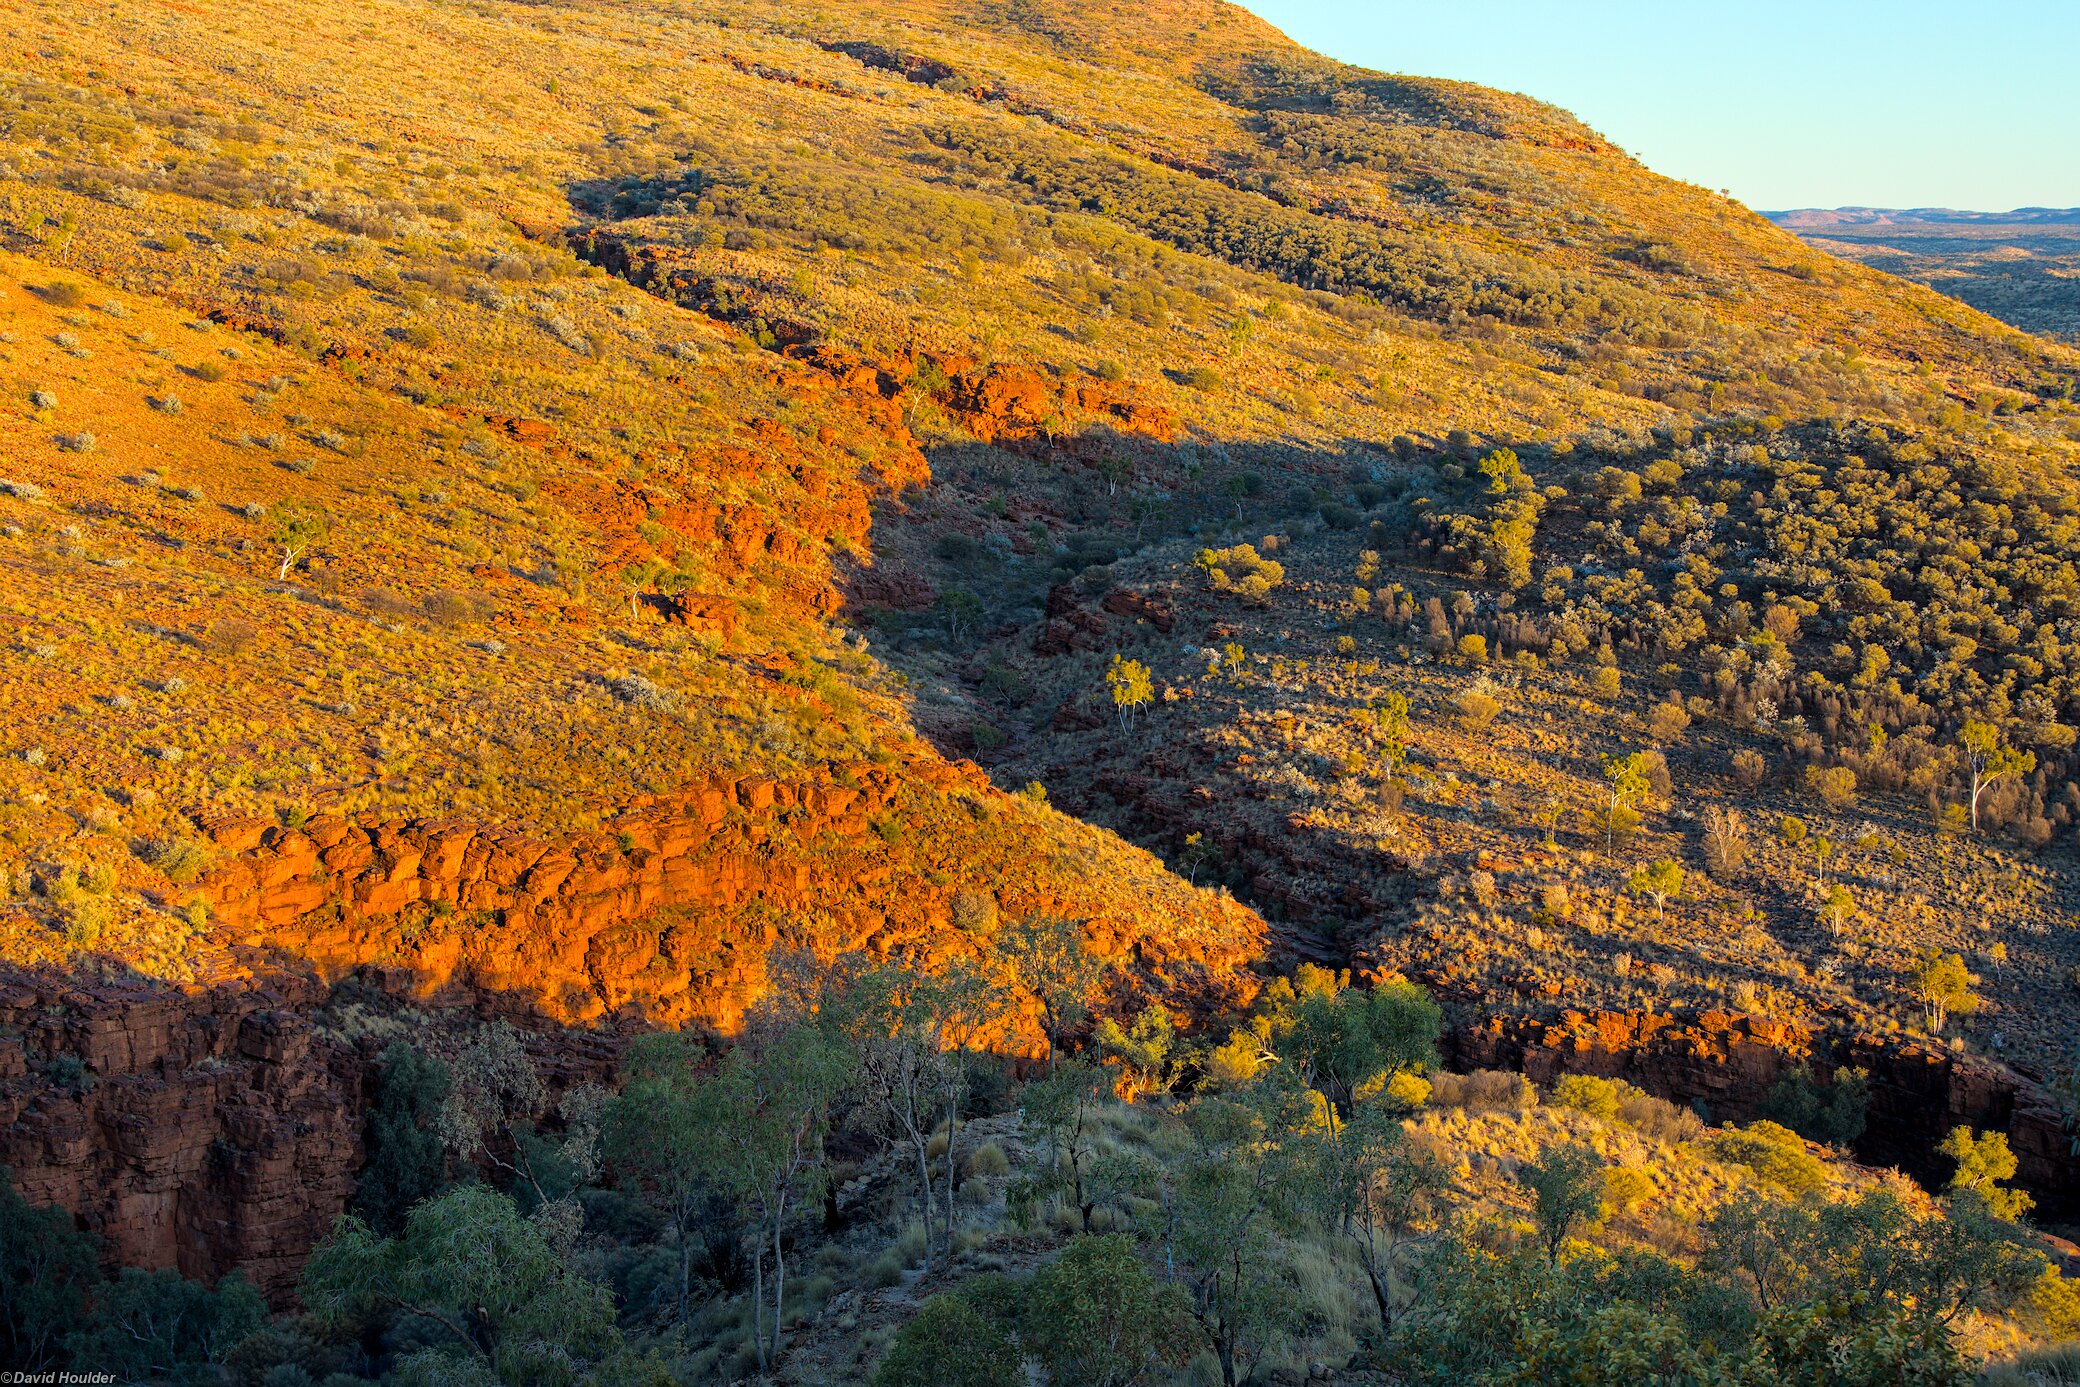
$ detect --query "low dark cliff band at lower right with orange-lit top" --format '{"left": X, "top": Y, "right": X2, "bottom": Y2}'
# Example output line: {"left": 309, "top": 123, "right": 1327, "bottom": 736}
{"left": 1450, "top": 1011, "right": 2080, "bottom": 1219}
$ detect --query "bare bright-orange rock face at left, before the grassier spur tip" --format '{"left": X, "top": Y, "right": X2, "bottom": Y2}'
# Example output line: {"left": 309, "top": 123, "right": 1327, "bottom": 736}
{"left": 193, "top": 767, "right": 896, "bottom": 1031}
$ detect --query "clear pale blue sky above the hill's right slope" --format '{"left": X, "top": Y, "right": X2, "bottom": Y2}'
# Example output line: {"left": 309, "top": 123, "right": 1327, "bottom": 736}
{"left": 1242, "top": 0, "right": 2080, "bottom": 210}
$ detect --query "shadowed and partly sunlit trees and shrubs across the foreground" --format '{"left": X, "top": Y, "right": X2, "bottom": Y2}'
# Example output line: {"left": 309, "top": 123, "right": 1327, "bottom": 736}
{"left": 0, "top": 960, "right": 2080, "bottom": 1387}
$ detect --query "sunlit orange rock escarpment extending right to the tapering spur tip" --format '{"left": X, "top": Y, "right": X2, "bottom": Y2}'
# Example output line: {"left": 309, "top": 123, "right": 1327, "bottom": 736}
{"left": 204, "top": 757, "right": 1263, "bottom": 1033}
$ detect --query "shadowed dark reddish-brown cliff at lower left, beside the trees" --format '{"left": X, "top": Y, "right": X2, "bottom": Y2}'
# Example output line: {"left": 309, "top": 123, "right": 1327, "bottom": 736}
{"left": 0, "top": 975, "right": 368, "bottom": 1298}
